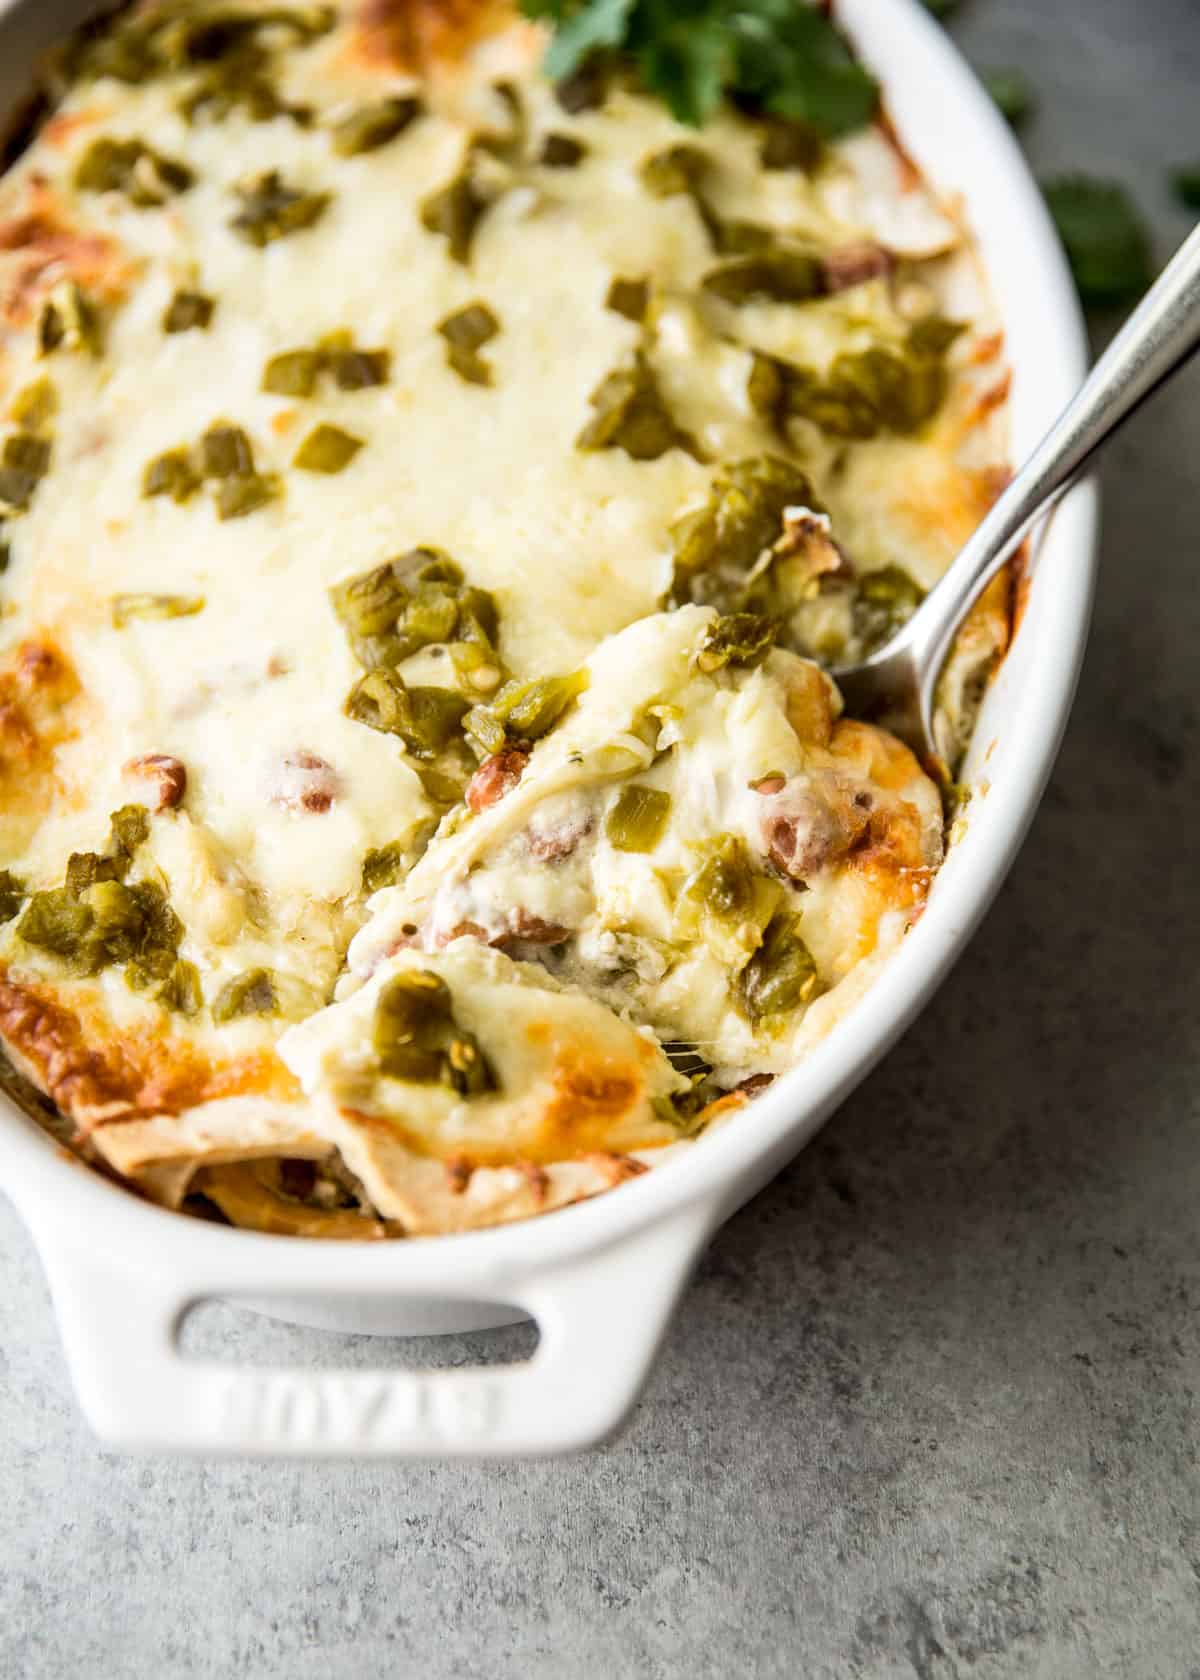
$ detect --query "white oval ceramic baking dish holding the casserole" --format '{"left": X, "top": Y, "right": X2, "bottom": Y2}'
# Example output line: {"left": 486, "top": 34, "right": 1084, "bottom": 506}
{"left": 0, "top": 0, "right": 1096, "bottom": 1455}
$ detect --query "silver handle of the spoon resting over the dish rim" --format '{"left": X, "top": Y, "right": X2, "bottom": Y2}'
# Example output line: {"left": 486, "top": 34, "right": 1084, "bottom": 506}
{"left": 903, "top": 227, "right": 1200, "bottom": 690}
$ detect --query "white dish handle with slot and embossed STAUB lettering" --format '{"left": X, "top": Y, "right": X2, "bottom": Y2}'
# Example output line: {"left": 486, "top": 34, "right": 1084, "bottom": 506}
{"left": 35, "top": 1206, "right": 711, "bottom": 1457}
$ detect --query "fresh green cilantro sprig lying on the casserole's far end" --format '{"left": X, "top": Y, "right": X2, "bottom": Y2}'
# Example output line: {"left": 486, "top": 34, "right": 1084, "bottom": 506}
{"left": 521, "top": 0, "right": 879, "bottom": 139}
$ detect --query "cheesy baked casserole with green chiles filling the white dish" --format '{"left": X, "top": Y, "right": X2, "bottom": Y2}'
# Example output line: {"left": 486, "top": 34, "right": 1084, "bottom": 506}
{"left": 0, "top": 0, "right": 1008, "bottom": 1236}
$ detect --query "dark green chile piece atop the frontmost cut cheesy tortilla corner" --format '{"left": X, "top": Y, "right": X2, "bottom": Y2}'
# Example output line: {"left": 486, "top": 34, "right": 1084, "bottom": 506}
{"left": 371, "top": 968, "right": 496, "bottom": 1097}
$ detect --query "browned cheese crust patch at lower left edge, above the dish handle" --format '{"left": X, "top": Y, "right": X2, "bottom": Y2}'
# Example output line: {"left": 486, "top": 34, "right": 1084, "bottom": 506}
{"left": 0, "top": 969, "right": 299, "bottom": 1136}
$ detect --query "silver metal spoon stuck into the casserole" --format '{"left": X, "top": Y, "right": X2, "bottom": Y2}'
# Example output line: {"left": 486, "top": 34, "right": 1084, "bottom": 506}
{"left": 834, "top": 227, "right": 1200, "bottom": 759}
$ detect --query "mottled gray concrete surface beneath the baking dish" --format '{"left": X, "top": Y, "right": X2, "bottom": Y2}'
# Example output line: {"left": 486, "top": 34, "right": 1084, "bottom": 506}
{"left": 0, "top": 0, "right": 1200, "bottom": 1680}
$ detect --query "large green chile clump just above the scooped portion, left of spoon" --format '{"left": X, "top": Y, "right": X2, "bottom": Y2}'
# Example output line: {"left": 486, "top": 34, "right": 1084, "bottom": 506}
{"left": 671, "top": 455, "right": 820, "bottom": 612}
